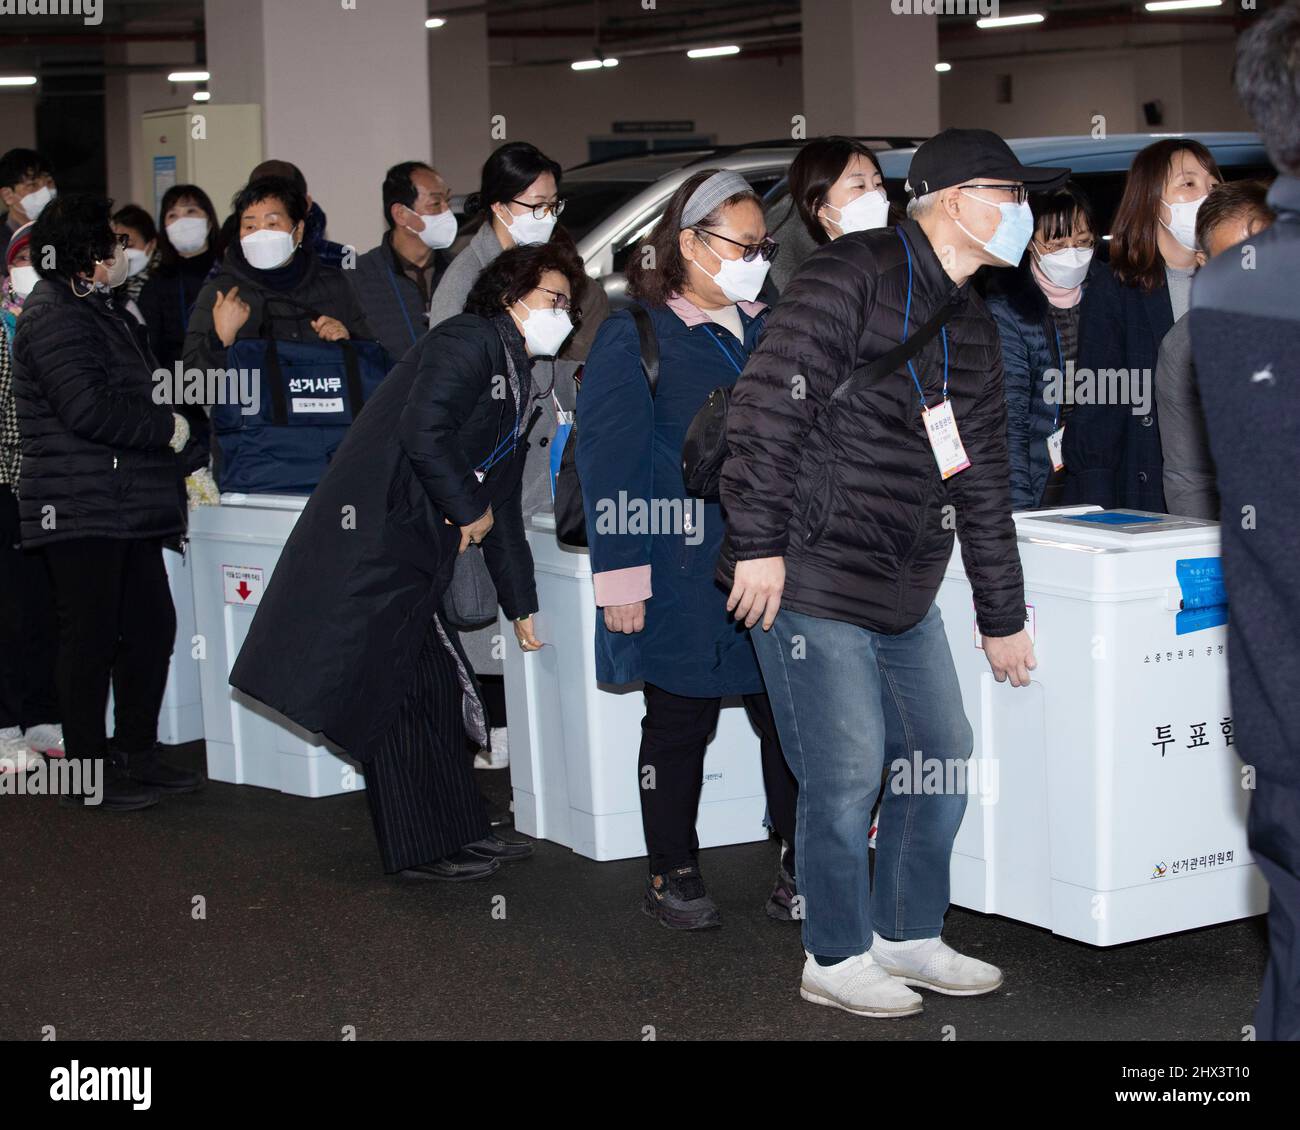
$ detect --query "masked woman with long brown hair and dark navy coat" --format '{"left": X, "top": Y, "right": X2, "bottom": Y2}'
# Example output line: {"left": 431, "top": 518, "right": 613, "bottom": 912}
{"left": 1062, "top": 138, "right": 1223, "bottom": 514}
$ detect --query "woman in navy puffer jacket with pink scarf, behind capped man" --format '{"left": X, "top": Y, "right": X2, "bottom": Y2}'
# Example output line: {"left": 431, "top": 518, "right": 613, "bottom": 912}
{"left": 984, "top": 183, "right": 1105, "bottom": 510}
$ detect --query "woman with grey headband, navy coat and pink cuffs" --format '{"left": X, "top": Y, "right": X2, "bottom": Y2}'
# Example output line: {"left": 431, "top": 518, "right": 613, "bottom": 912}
{"left": 577, "top": 170, "right": 796, "bottom": 930}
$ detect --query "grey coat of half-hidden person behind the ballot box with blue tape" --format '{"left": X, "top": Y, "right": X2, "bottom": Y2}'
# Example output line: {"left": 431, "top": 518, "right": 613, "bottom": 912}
{"left": 1156, "top": 315, "right": 1219, "bottom": 521}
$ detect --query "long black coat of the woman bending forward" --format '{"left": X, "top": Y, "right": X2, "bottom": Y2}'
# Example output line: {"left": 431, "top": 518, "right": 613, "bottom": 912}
{"left": 230, "top": 315, "right": 537, "bottom": 761}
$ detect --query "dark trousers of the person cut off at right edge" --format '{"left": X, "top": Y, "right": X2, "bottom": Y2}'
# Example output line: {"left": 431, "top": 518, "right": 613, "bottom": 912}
{"left": 1245, "top": 780, "right": 1300, "bottom": 1040}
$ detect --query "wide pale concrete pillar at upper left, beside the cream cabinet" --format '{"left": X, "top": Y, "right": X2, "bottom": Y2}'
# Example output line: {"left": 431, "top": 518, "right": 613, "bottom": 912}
{"left": 204, "top": 0, "right": 430, "bottom": 251}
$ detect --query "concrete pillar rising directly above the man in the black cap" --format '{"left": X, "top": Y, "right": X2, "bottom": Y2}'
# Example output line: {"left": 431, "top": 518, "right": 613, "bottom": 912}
{"left": 803, "top": 0, "right": 939, "bottom": 138}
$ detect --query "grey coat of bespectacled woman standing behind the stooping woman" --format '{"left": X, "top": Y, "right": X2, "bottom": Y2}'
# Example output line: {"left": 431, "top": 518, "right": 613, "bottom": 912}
{"left": 429, "top": 224, "right": 610, "bottom": 675}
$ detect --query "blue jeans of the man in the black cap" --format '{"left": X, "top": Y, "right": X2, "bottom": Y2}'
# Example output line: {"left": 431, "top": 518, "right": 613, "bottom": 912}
{"left": 750, "top": 605, "right": 974, "bottom": 957}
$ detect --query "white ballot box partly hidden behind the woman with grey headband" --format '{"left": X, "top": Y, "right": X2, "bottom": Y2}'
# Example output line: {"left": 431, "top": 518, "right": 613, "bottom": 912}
{"left": 501, "top": 514, "right": 767, "bottom": 860}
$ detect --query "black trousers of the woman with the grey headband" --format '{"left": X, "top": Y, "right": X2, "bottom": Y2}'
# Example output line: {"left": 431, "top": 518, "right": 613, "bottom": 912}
{"left": 637, "top": 683, "right": 798, "bottom": 875}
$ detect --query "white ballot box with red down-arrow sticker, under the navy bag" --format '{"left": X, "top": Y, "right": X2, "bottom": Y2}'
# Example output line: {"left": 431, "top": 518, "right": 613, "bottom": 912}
{"left": 190, "top": 494, "right": 364, "bottom": 797}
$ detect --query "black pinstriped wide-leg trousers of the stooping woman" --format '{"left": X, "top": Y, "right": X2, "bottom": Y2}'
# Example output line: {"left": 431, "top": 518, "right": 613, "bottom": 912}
{"left": 365, "top": 619, "right": 491, "bottom": 874}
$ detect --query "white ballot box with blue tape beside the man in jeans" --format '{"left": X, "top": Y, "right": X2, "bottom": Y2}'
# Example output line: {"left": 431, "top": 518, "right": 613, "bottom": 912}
{"left": 922, "top": 507, "right": 1266, "bottom": 945}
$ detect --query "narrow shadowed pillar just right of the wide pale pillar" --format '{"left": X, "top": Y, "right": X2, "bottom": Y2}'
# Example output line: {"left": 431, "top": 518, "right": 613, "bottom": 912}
{"left": 429, "top": 10, "right": 488, "bottom": 195}
